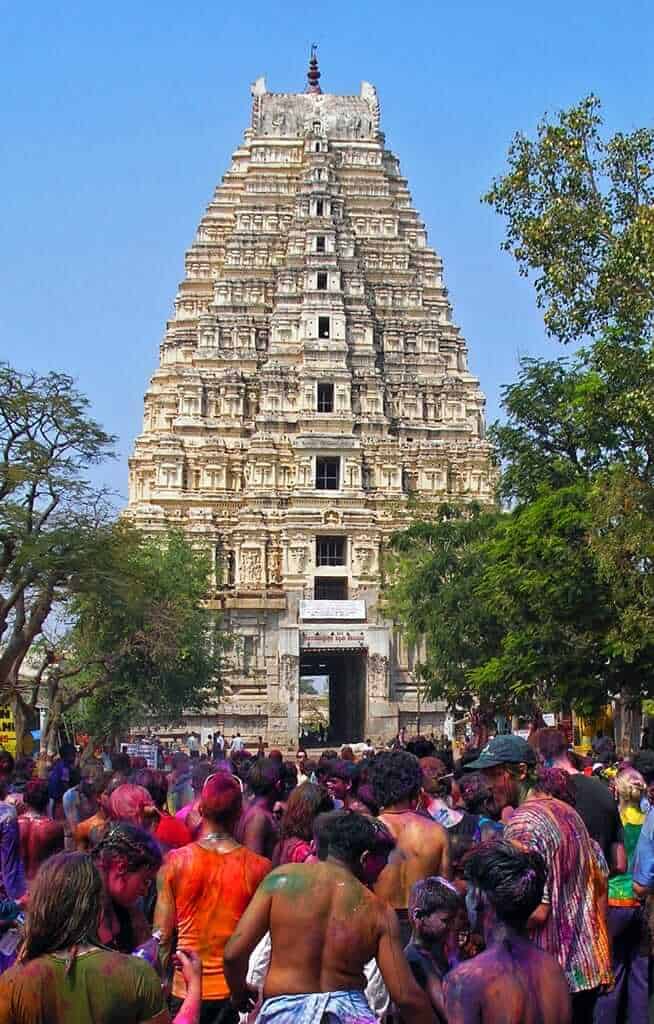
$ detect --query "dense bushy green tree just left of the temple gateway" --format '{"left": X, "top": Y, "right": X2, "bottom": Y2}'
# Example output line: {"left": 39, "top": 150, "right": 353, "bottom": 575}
{"left": 57, "top": 522, "right": 227, "bottom": 743}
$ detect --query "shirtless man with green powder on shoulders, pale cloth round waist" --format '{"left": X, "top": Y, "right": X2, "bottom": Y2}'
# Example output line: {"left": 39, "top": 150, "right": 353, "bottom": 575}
{"left": 224, "top": 812, "right": 434, "bottom": 1024}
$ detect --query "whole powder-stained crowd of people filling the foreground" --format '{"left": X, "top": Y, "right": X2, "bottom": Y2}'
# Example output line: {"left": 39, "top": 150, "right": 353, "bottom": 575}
{"left": 0, "top": 727, "right": 654, "bottom": 1024}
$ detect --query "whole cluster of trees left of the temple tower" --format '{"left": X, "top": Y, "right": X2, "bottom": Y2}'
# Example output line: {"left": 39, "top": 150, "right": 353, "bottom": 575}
{"left": 0, "top": 365, "right": 221, "bottom": 742}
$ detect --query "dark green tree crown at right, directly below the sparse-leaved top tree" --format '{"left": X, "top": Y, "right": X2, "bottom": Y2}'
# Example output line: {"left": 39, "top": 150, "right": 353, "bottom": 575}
{"left": 489, "top": 329, "right": 654, "bottom": 502}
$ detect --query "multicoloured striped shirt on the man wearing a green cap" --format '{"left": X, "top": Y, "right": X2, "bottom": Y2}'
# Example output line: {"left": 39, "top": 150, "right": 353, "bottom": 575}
{"left": 505, "top": 796, "right": 613, "bottom": 992}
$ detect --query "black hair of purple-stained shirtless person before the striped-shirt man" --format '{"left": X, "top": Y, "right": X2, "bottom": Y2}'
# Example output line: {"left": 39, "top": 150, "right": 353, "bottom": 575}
{"left": 464, "top": 840, "right": 548, "bottom": 929}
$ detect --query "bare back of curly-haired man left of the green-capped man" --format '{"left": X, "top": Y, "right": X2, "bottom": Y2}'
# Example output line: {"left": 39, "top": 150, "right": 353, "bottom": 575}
{"left": 375, "top": 810, "right": 450, "bottom": 909}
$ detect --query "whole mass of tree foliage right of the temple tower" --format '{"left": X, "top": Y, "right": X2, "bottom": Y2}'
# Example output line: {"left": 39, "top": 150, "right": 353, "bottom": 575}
{"left": 387, "top": 97, "right": 654, "bottom": 714}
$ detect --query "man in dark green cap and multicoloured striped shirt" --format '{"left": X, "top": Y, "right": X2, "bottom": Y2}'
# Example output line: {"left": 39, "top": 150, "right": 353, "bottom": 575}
{"left": 466, "top": 735, "right": 613, "bottom": 1024}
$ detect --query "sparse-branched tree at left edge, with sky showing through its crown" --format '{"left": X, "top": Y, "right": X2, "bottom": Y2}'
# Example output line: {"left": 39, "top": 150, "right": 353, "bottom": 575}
{"left": 0, "top": 364, "right": 115, "bottom": 738}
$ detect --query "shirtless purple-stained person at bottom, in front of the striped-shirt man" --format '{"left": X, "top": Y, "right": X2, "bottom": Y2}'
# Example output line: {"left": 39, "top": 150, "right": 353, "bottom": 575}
{"left": 444, "top": 840, "right": 572, "bottom": 1024}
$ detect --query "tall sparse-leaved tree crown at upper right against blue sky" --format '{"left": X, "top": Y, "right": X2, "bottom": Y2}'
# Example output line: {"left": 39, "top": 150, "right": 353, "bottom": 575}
{"left": 484, "top": 96, "right": 654, "bottom": 342}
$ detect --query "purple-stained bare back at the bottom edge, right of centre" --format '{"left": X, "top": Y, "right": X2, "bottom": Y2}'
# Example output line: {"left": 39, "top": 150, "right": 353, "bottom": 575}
{"left": 444, "top": 937, "right": 571, "bottom": 1024}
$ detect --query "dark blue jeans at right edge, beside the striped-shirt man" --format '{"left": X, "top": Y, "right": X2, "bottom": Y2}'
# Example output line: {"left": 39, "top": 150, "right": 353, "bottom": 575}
{"left": 594, "top": 906, "right": 649, "bottom": 1024}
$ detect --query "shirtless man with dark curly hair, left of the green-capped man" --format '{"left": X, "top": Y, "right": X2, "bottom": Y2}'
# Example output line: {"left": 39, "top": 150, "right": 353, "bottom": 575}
{"left": 372, "top": 751, "right": 450, "bottom": 946}
